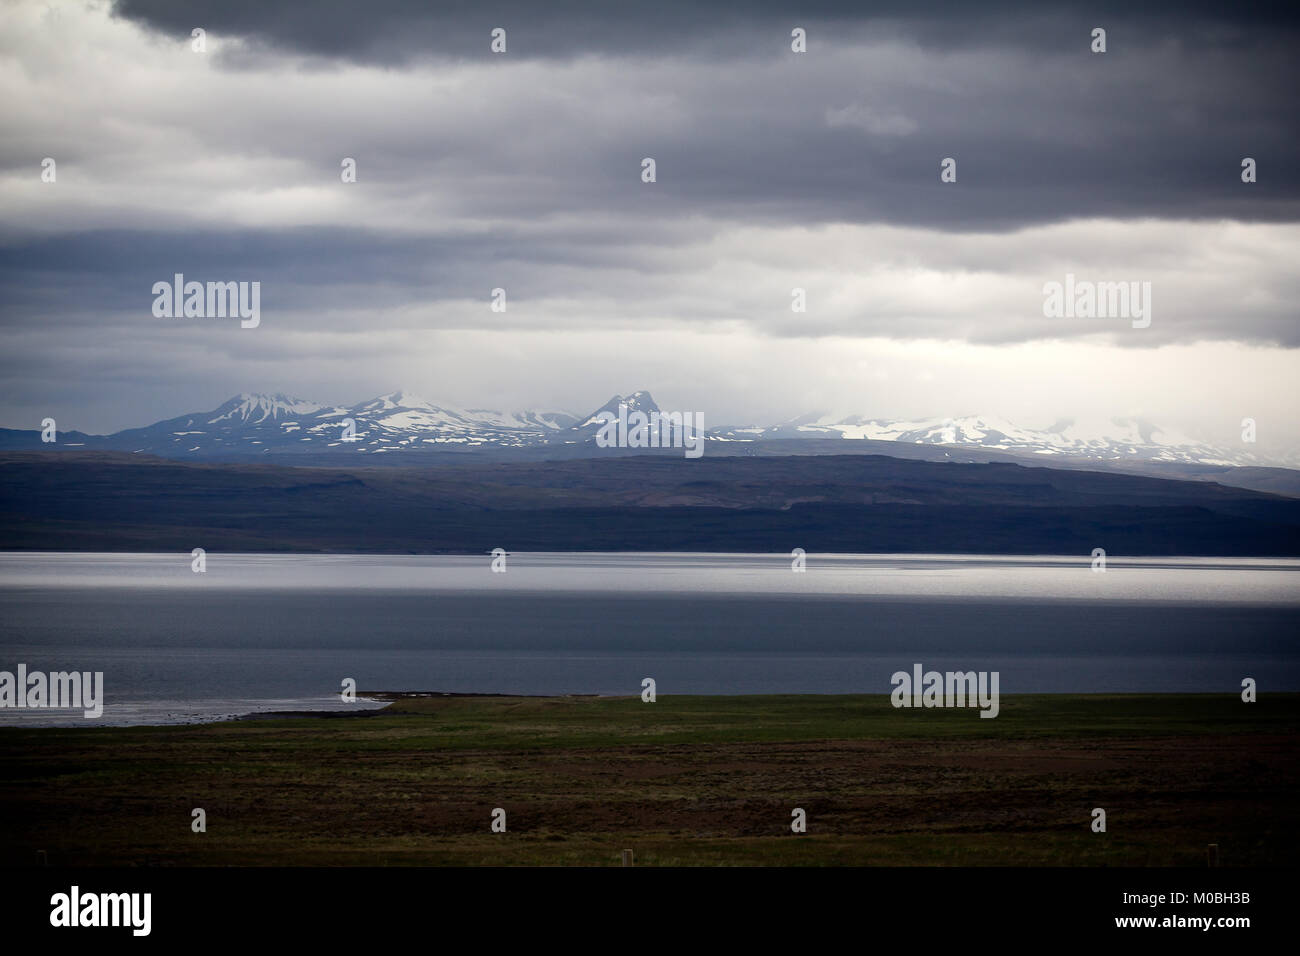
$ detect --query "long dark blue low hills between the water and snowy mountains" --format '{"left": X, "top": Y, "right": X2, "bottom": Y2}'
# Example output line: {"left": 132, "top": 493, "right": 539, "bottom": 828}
{"left": 0, "top": 451, "right": 1300, "bottom": 557}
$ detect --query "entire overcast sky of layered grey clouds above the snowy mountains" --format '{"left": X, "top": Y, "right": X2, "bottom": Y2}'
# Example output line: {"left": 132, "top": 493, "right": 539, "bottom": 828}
{"left": 0, "top": 0, "right": 1300, "bottom": 463}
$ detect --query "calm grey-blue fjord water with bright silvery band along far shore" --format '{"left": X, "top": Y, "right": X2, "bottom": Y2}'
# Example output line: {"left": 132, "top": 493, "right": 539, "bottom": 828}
{"left": 0, "top": 553, "right": 1300, "bottom": 726}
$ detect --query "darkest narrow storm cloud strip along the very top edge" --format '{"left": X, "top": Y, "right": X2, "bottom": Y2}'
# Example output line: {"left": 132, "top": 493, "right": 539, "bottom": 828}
{"left": 114, "top": 0, "right": 1300, "bottom": 62}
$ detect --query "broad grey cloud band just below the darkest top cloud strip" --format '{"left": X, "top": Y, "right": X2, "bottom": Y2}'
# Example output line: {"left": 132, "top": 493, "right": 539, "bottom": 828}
{"left": 0, "top": 26, "right": 1300, "bottom": 235}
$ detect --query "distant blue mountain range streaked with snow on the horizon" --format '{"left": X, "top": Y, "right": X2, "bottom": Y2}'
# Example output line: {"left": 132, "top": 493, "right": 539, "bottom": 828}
{"left": 0, "top": 390, "right": 1300, "bottom": 467}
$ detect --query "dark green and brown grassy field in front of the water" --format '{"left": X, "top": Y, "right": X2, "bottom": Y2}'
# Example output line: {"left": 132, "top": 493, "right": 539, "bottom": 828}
{"left": 0, "top": 693, "right": 1300, "bottom": 866}
